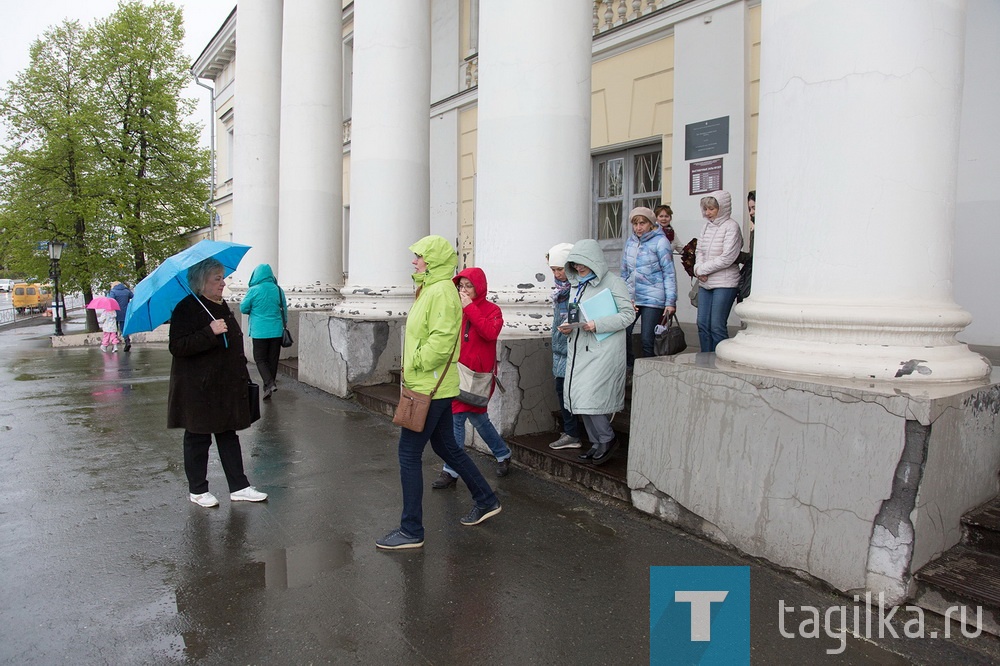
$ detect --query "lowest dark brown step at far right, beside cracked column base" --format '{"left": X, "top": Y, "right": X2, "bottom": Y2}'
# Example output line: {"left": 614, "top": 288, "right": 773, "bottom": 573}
{"left": 914, "top": 545, "right": 1000, "bottom": 635}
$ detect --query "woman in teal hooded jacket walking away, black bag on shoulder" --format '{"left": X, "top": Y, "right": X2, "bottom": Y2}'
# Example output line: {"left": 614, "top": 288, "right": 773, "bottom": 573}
{"left": 240, "top": 264, "right": 288, "bottom": 400}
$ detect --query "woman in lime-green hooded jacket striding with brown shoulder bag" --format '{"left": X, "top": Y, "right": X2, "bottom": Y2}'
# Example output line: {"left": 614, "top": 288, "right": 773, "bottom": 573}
{"left": 375, "top": 236, "right": 500, "bottom": 550}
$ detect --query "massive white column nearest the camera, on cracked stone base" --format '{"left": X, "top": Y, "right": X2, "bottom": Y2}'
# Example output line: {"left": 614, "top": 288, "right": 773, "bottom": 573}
{"left": 718, "top": 0, "right": 990, "bottom": 383}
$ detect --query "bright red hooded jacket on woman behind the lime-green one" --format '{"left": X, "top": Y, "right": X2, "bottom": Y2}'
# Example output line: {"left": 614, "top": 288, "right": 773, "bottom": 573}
{"left": 451, "top": 266, "right": 503, "bottom": 414}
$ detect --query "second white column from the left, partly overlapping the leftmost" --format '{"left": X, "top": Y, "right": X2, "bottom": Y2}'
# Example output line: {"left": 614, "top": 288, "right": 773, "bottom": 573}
{"left": 278, "top": 0, "right": 344, "bottom": 306}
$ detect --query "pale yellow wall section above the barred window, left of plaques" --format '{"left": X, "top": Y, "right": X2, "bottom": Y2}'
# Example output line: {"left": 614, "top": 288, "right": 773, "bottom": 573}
{"left": 590, "top": 36, "right": 674, "bottom": 201}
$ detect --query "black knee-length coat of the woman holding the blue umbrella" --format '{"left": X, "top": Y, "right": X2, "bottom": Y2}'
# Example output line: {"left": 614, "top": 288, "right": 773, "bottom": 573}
{"left": 167, "top": 296, "right": 250, "bottom": 433}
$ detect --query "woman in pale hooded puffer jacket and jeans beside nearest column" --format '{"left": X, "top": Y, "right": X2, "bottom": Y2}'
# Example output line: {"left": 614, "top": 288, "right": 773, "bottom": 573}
{"left": 694, "top": 190, "right": 743, "bottom": 352}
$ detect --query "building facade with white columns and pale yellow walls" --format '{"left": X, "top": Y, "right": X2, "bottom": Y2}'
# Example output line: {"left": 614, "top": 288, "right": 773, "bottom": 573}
{"left": 194, "top": 0, "right": 1000, "bottom": 597}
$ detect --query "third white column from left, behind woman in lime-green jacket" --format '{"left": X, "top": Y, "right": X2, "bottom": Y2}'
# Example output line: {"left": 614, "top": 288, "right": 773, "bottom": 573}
{"left": 336, "top": 0, "right": 431, "bottom": 318}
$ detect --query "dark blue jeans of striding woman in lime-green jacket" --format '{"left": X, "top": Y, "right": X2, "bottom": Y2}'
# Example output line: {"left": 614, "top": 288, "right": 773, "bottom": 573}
{"left": 399, "top": 398, "right": 497, "bottom": 539}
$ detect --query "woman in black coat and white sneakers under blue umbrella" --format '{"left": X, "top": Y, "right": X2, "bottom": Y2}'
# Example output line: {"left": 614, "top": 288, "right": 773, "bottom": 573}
{"left": 167, "top": 258, "right": 267, "bottom": 507}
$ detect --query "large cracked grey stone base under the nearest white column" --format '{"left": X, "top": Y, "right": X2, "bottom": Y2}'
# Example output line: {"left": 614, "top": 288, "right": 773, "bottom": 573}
{"left": 628, "top": 354, "right": 1000, "bottom": 603}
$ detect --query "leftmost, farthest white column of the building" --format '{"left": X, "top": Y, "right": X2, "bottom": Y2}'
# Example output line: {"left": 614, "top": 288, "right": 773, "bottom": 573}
{"left": 233, "top": 0, "right": 281, "bottom": 285}
